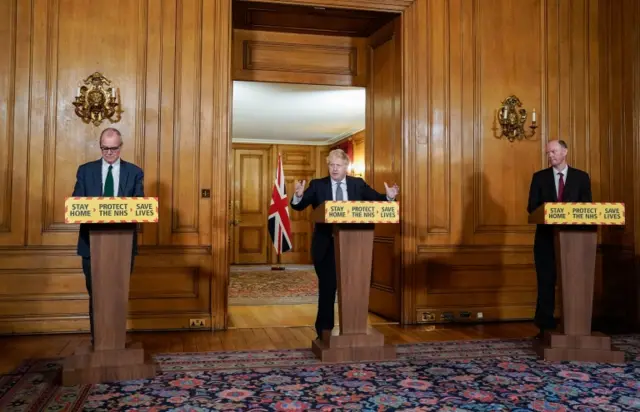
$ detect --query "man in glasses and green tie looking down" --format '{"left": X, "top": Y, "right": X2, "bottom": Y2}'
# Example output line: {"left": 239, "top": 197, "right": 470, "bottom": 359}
{"left": 72, "top": 128, "right": 144, "bottom": 344}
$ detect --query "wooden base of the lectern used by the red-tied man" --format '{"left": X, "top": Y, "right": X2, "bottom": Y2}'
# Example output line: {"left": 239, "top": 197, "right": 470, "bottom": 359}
{"left": 534, "top": 332, "right": 624, "bottom": 363}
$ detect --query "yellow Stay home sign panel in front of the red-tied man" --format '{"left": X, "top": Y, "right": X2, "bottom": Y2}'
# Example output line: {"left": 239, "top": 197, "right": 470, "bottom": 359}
{"left": 544, "top": 203, "right": 625, "bottom": 225}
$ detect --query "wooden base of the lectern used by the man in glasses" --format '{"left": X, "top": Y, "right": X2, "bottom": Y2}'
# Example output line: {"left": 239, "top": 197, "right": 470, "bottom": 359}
{"left": 62, "top": 343, "right": 157, "bottom": 386}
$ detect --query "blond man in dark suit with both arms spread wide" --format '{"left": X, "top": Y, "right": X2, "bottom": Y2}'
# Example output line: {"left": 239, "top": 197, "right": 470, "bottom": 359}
{"left": 291, "top": 149, "right": 399, "bottom": 339}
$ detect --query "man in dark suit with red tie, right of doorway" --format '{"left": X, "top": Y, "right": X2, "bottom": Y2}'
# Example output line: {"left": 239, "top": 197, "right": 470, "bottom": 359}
{"left": 527, "top": 140, "right": 592, "bottom": 339}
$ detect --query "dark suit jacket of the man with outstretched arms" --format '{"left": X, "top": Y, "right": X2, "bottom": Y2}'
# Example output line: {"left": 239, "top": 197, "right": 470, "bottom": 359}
{"left": 291, "top": 176, "right": 387, "bottom": 262}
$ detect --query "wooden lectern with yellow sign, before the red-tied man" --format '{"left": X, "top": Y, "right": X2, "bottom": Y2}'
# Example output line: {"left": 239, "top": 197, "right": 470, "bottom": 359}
{"left": 529, "top": 203, "right": 625, "bottom": 363}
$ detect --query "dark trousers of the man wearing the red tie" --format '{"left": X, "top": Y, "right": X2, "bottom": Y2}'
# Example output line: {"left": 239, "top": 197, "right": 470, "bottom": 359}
{"left": 533, "top": 232, "right": 557, "bottom": 329}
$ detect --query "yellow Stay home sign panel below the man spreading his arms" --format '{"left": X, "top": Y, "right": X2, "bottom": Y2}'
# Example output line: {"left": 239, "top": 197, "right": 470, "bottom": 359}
{"left": 324, "top": 201, "right": 400, "bottom": 223}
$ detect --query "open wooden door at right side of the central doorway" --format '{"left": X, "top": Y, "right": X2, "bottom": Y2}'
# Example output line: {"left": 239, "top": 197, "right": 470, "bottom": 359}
{"left": 365, "top": 18, "right": 402, "bottom": 321}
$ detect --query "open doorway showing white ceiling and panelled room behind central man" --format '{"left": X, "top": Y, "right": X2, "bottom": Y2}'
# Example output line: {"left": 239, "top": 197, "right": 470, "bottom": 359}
{"left": 229, "top": 81, "right": 386, "bottom": 328}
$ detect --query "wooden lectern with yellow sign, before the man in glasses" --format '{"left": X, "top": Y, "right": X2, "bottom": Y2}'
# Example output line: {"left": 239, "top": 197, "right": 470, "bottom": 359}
{"left": 62, "top": 197, "right": 158, "bottom": 386}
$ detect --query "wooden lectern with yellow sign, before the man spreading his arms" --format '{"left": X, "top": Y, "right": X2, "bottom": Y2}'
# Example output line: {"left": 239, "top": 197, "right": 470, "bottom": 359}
{"left": 311, "top": 201, "right": 399, "bottom": 362}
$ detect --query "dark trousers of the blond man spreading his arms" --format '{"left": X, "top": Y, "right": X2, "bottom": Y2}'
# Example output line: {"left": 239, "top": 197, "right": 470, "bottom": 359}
{"left": 313, "top": 239, "right": 337, "bottom": 337}
